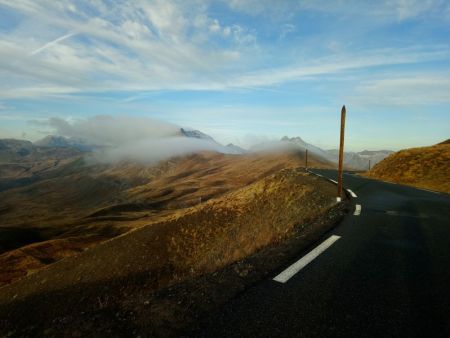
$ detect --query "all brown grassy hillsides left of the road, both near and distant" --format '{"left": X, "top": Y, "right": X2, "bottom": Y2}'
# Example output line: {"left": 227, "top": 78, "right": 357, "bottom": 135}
{"left": 0, "top": 142, "right": 344, "bottom": 337}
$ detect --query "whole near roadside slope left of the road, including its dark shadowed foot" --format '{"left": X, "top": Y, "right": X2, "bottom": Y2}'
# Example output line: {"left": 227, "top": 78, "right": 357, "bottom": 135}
{"left": 0, "top": 168, "right": 345, "bottom": 337}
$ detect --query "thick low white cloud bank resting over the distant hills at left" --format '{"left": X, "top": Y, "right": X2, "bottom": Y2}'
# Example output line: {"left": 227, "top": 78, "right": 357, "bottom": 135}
{"left": 47, "top": 115, "right": 227, "bottom": 164}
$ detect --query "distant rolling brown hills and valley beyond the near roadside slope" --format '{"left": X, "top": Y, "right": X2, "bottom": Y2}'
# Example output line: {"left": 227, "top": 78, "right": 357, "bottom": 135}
{"left": 0, "top": 149, "right": 329, "bottom": 285}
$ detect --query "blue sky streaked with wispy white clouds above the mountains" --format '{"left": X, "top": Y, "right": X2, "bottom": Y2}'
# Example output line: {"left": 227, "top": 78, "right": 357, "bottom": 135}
{"left": 0, "top": 0, "right": 450, "bottom": 151}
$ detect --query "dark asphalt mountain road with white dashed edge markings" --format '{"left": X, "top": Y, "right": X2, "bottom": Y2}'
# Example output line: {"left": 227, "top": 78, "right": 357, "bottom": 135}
{"left": 189, "top": 170, "right": 450, "bottom": 337}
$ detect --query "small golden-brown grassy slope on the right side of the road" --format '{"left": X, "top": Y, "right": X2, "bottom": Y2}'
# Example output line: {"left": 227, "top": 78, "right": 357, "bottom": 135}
{"left": 368, "top": 140, "right": 450, "bottom": 194}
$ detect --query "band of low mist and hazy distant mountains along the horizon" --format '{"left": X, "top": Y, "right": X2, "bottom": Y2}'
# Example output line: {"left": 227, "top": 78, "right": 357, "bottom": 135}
{"left": 0, "top": 115, "right": 392, "bottom": 170}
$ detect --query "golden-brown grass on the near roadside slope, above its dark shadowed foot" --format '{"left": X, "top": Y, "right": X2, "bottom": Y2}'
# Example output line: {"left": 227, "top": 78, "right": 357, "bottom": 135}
{"left": 0, "top": 169, "right": 335, "bottom": 303}
